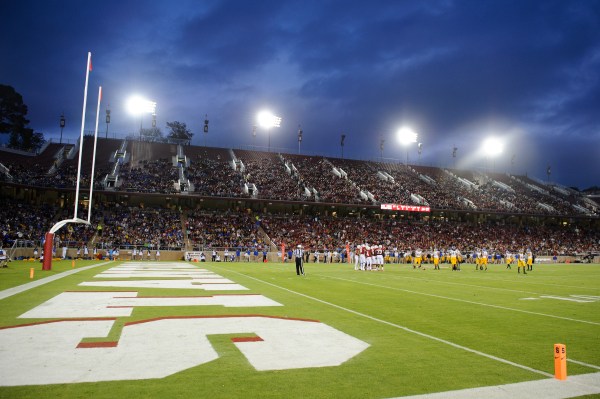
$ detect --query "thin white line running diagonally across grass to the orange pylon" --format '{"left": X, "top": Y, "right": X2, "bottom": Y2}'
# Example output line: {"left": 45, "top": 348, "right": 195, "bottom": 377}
{"left": 217, "top": 266, "right": 553, "bottom": 377}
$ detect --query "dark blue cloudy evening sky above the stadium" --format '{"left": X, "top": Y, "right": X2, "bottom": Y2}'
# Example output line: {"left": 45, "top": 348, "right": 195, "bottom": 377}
{"left": 0, "top": 0, "right": 600, "bottom": 189}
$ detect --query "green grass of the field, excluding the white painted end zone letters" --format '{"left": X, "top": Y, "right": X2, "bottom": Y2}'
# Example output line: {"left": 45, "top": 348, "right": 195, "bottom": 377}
{"left": 0, "top": 261, "right": 600, "bottom": 399}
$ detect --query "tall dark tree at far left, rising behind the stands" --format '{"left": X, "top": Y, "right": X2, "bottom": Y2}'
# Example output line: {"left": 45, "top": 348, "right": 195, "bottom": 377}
{"left": 0, "top": 84, "right": 46, "bottom": 152}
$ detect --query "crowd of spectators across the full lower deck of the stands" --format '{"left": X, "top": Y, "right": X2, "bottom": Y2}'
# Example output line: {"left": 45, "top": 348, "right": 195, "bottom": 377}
{"left": 0, "top": 198, "right": 600, "bottom": 255}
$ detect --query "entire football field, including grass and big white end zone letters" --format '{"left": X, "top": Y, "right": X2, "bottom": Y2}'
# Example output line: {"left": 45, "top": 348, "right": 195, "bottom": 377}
{"left": 0, "top": 261, "right": 600, "bottom": 399}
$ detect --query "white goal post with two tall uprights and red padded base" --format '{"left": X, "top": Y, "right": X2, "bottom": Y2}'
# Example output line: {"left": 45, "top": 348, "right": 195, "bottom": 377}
{"left": 42, "top": 52, "right": 102, "bottom": 270}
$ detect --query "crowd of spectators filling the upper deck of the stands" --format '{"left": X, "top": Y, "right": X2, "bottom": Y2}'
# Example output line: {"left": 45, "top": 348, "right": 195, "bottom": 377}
{"left": 0, "top": 140, "right": 598, "bottom": 216}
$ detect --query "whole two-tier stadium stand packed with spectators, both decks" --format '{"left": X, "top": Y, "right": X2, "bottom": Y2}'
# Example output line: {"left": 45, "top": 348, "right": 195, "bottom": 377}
{"left": 0, "top": 137, "right": 600, "bottom": 262}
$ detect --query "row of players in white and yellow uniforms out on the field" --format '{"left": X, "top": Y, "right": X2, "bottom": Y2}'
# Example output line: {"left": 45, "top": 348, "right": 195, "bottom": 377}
{"left": 353, "top": 244, "right": 535, "bottom": 274}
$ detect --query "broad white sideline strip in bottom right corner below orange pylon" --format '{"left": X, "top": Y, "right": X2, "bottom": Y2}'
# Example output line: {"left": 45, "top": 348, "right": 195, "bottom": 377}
{"left": 394, "top": 373, "right": 600, "bottom": 399}
